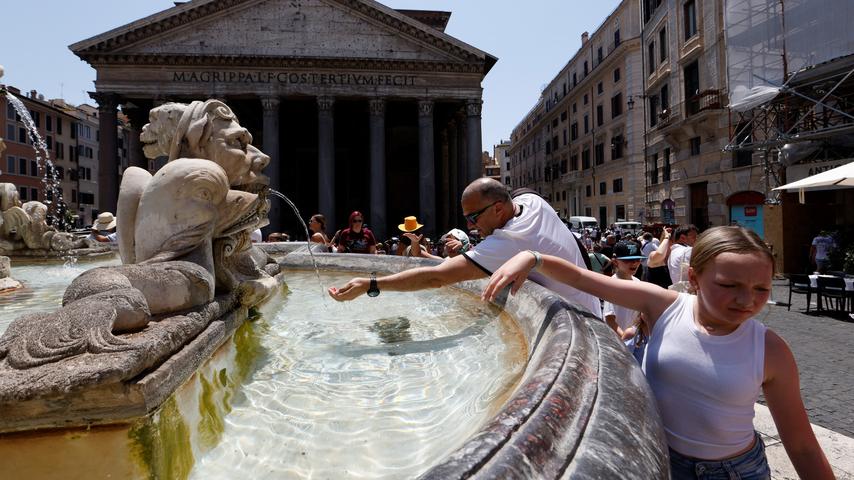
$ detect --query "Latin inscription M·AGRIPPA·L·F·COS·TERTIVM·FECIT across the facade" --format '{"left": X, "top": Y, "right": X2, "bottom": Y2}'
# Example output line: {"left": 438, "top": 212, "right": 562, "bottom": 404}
{"left": 172, "top": 70, "right": 415, "bottom": 87}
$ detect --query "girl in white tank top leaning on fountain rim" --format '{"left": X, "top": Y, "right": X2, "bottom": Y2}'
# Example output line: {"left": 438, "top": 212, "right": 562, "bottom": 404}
{"left": 483, "top": 227, "right": 834, "bottom": 478}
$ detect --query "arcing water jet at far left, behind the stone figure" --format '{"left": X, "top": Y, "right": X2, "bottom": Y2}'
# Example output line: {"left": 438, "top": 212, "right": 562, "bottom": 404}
{"left": 4, "top": 91, "right": 70, "bottom": 231}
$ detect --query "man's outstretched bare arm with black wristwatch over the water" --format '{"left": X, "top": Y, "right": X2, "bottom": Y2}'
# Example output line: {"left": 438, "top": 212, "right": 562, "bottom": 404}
{"left": 328, "top": 255, "right": 487, "bottom": 302}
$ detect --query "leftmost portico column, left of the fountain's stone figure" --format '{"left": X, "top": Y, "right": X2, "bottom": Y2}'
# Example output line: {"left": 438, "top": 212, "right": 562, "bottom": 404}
{"left": 89, "top": 92, "right": 119, "bottom": 213}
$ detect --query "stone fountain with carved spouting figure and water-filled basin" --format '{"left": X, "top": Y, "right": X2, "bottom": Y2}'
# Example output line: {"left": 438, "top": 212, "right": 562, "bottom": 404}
{"left": 0, "top": 95, "right": 667, "bottom": 479}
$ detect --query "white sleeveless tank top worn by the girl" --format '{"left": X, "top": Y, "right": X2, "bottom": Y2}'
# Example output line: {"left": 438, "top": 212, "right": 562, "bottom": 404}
{"left": 642, "top": 293, "right": 766, "bottom": 459}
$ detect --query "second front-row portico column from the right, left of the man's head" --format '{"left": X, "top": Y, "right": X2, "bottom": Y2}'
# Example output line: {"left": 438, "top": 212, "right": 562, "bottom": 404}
{"left": 418, "top": 100, "right": 437, "bottom": 237}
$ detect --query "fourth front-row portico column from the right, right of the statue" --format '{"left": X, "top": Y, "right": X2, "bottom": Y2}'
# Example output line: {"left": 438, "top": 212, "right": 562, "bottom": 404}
{"left": 317, "top": 97, "right": 338, "bottom": 231}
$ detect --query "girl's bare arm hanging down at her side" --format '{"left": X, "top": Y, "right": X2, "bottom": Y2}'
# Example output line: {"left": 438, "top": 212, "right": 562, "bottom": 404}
{"left": 762, "top": 330, "right": 834, "bottom": 479}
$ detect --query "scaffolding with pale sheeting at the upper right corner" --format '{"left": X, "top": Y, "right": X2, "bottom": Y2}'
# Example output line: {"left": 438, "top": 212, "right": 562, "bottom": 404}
{"left": 726, "top": 0, "right": 854, "bottom": 203}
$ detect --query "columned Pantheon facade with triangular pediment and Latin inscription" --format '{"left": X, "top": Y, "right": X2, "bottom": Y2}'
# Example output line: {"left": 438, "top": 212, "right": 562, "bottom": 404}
{"left": 76, "top": 0, "right": 496, "bottom": 238}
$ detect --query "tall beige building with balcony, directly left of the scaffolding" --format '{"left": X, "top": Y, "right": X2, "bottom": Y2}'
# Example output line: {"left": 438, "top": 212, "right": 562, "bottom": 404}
{"left": 642, "top": 0, "right": 765, "bottom": 231}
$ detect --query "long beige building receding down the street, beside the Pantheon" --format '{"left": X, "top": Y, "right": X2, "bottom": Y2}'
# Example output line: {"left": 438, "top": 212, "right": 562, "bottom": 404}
{"left": 509, "top": 0, "right": 645, "bottom": 226}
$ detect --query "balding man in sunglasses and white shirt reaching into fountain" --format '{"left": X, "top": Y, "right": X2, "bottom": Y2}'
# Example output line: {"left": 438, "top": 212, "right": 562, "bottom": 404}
{"left": 329, "top": 178, "right": 601, "bottom": 318}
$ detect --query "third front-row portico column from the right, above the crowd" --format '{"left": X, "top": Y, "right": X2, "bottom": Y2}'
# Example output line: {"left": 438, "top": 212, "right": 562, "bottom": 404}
{"left": 368, "top": 98, "right": 388, "bottom": 238}
